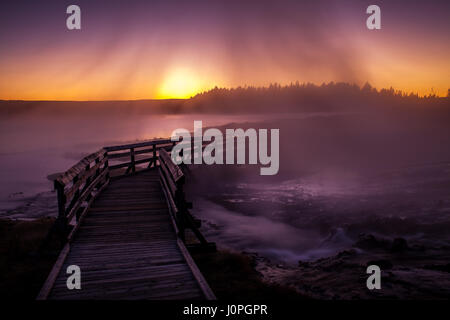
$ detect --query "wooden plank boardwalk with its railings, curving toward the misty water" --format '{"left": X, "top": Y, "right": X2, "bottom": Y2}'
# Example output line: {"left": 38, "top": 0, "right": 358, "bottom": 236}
{"left": 37, "top": 140, "right": 215, "bottom": 300}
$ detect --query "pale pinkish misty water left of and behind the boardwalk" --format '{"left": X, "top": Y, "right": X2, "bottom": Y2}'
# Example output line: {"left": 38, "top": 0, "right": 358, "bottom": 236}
{"left": 0, "top": 112, "right": 278, "bottom": 215}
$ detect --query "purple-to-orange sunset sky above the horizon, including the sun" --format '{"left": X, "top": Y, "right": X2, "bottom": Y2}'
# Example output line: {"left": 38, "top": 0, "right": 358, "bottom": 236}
{"left": 0, "top": 0, "right": 450, "bottom": 100}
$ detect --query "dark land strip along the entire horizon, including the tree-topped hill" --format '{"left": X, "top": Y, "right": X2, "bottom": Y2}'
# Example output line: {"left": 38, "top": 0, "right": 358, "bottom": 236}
{"left": 0, "top": 82, "right": 450, "bottom": 119}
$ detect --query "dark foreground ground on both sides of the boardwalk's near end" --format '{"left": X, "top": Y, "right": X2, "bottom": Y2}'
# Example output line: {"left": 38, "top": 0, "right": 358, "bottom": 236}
{"left": 0, "top": 218, "right": 450, "bottom": 300}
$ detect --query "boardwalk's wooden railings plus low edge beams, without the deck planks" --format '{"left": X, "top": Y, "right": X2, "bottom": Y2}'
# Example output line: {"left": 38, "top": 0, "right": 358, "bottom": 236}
{"left": 41, "top": 136, "right": 216, "bottom": 300}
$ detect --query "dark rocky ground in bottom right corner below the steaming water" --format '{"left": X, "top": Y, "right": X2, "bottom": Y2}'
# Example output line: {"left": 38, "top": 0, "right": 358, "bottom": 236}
{"left": 247, "top": 235, "right": 450, "bottom": 300}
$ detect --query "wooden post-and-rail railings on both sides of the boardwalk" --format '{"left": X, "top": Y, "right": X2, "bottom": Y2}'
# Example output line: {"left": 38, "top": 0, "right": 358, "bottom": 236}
{"left": 54, "top": 139, "right": 215, "bottom": 250}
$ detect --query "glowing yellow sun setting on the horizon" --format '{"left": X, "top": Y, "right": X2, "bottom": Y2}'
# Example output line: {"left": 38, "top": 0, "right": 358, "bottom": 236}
{"left": 157, "top": 69, "right": 202, "bottom": 99}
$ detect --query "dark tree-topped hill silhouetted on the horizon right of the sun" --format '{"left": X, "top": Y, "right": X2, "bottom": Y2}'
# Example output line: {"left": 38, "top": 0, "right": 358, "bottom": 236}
{"left": 187, "top": 82, "right": 449, "bottom": 112}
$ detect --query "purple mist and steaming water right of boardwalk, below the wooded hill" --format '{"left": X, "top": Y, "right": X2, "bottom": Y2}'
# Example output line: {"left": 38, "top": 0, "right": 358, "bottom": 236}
{"left": 188, "top": 113, "right": 450, "bottom": 264}
